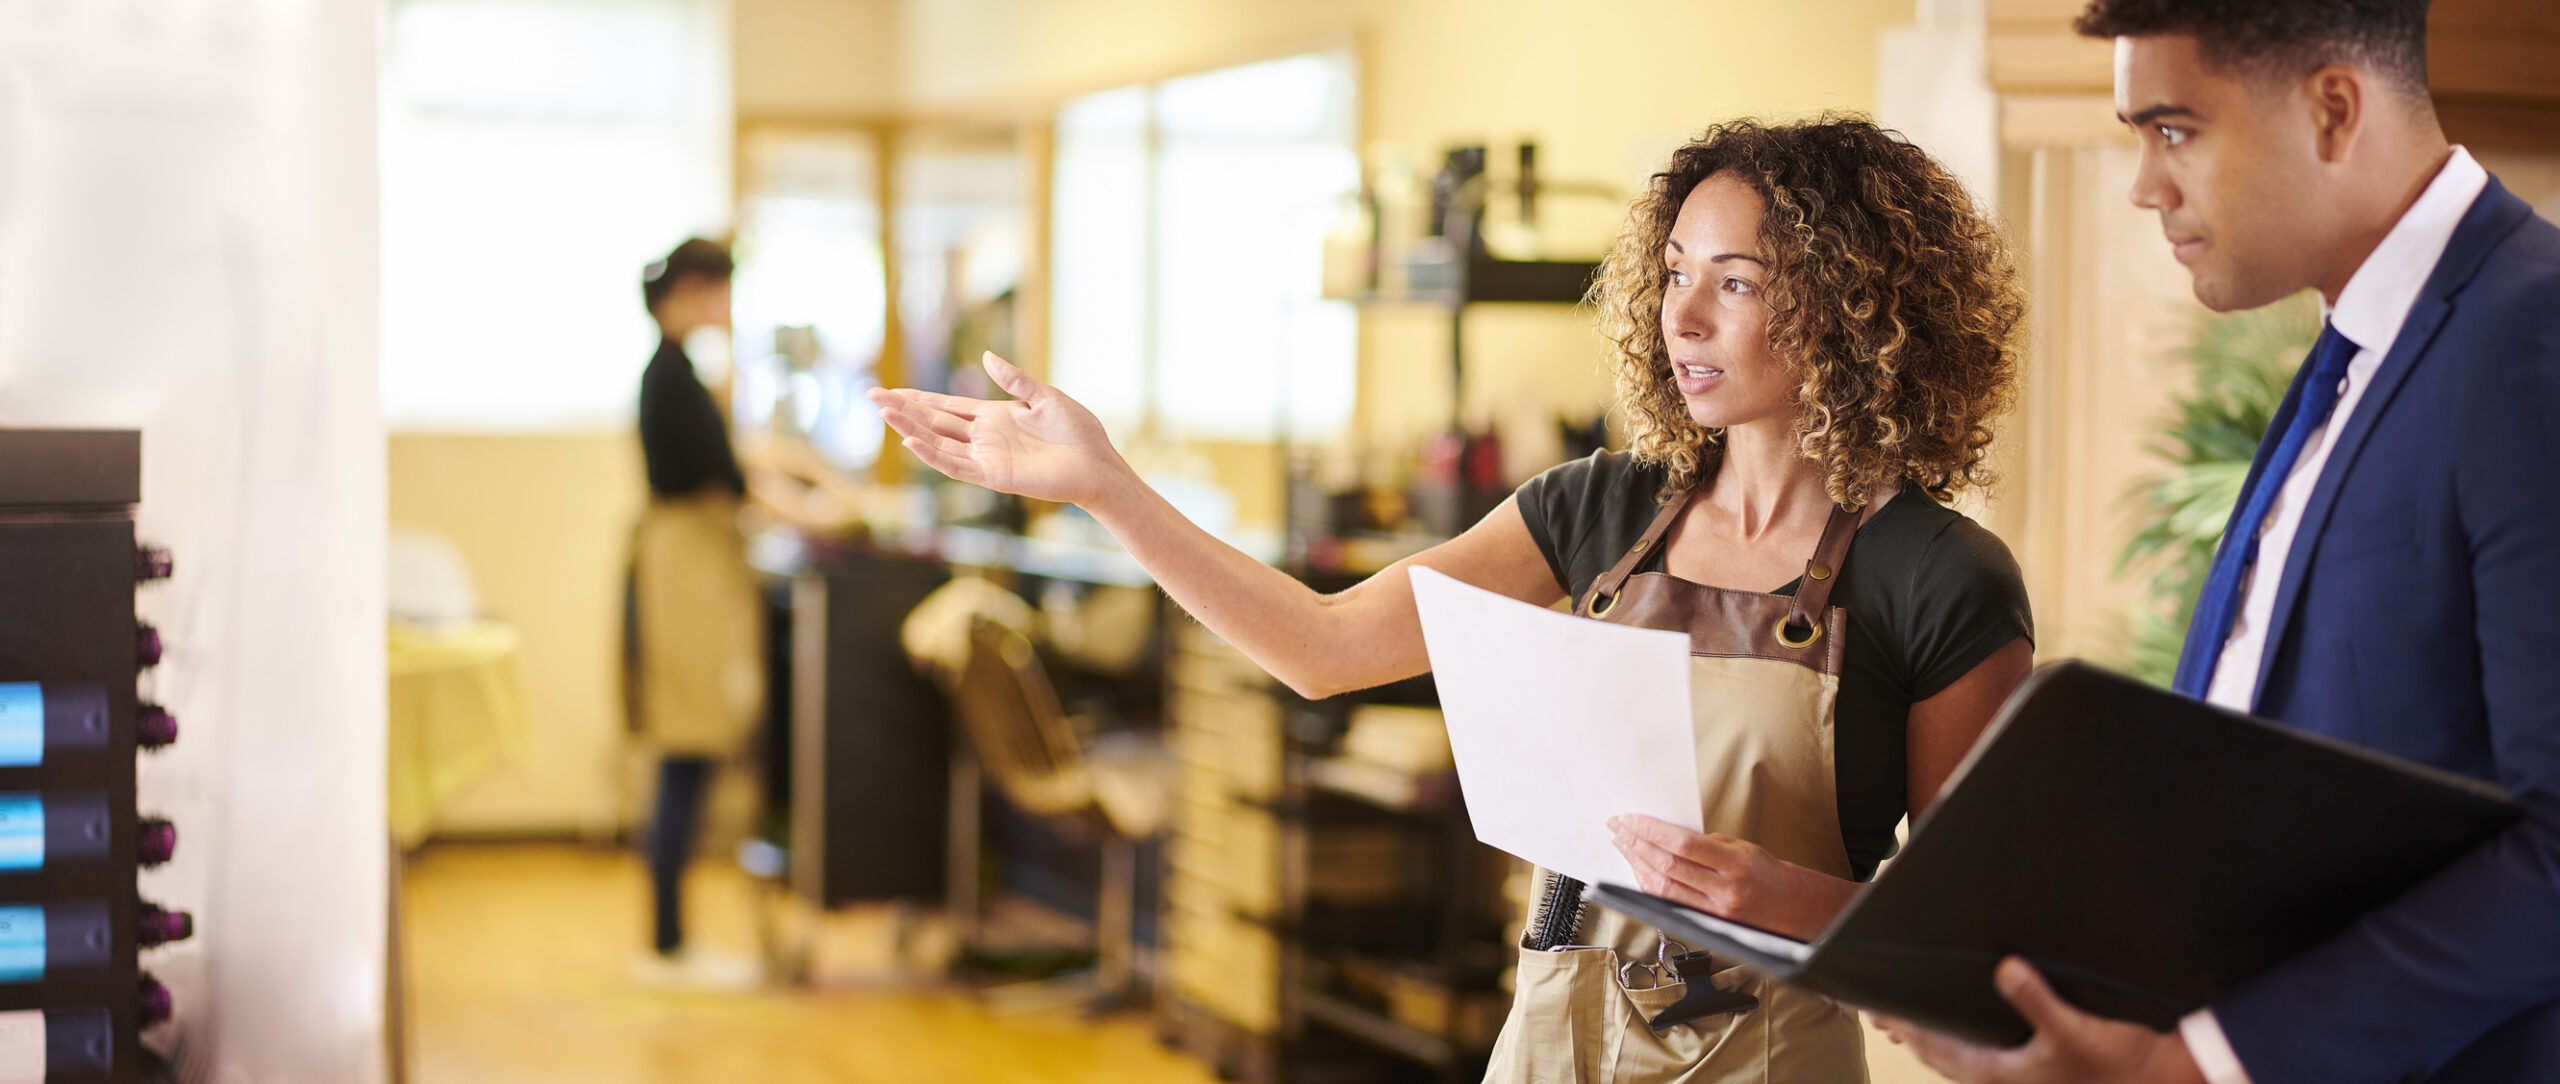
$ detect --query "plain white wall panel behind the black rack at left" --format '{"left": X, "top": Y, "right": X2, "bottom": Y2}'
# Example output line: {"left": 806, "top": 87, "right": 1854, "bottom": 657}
{"left": 0, "top": 0, "right": 387, "bottom": 1084}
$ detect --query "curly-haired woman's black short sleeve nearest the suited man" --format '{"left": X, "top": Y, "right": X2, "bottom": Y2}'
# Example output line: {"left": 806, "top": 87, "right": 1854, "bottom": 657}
{"left": 1902, "top": 515, "right": 2035, "bottom": 702}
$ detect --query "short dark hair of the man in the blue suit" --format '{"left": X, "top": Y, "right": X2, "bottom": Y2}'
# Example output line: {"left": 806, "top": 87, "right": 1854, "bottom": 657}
{"left": 2071, "top": 0, "right": 2427, "bottom": 97}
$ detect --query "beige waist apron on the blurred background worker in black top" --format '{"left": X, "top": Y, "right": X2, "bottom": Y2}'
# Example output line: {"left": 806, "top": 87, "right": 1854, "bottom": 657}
{"left": 632, "top": 495, "right": 765, "bottom": 759}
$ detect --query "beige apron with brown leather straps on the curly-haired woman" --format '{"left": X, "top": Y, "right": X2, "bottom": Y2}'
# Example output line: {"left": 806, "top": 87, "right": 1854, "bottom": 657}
{"left": 1485, "top": 492, "right": 1866, "bottom": 1084}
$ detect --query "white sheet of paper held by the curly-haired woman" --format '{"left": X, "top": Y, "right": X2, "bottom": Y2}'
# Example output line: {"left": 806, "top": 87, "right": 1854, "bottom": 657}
{"left": 1413, "top": 566, "right": 1705, "bottom": 884}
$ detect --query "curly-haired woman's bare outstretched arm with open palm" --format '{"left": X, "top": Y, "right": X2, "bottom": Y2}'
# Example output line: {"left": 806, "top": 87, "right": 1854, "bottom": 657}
{"left": 870, "top": 354, "right": 1564, "bottom": 697}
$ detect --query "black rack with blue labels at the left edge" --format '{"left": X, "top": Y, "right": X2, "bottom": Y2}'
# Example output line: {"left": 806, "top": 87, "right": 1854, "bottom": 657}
{"left": 0, "top": 431, "right": 195, "bottom": 1084}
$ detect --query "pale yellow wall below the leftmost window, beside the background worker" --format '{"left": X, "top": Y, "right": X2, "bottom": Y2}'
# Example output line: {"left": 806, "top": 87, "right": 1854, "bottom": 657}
{"left": 389, "top": 431, "right": 648, "bottom": 835}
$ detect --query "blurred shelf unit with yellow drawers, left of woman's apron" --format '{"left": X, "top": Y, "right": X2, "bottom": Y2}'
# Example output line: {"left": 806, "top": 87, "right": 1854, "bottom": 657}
{"left": 1160, "top": 620, "right": 1508, "bottom": 1081}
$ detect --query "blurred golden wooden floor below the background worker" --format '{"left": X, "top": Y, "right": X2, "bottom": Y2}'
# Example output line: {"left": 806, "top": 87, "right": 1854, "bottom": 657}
{"left": 402, "top": 843, "right": 1213, "bottom": 1084}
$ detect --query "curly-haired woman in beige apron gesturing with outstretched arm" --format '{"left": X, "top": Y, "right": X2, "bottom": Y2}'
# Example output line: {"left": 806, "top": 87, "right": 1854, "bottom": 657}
{"left": 873, "top": 118, "right": 2033, "bottom": 1084}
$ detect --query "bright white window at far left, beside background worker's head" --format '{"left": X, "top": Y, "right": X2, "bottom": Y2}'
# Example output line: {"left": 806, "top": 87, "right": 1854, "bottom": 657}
{"left": 381, "top": 0, "right": 732, "bottom": 431}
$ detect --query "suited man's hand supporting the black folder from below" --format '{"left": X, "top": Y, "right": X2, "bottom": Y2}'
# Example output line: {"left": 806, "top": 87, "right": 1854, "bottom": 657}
{"left": 1876, "top": 956, "right": 2204, "bottom": 1084}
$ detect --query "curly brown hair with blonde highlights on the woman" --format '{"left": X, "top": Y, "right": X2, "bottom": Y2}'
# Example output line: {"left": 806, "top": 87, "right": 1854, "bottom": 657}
{"left": 1590, "top": 115, "right": 2025, "bottom": 510}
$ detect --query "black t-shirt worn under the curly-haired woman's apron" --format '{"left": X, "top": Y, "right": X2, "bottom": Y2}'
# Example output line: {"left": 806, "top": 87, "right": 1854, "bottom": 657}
{"left": 1518, "top": 451, "right": 2035, "bottom": 882}
